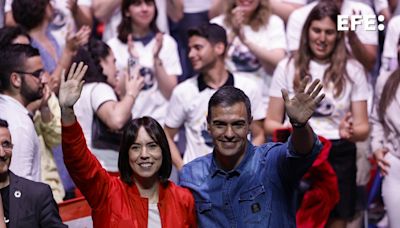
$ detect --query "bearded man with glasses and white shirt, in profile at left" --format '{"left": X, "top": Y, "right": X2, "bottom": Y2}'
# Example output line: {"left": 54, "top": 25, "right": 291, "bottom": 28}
{"left": 0, "top": 44, "right": 45, "bottom": 181}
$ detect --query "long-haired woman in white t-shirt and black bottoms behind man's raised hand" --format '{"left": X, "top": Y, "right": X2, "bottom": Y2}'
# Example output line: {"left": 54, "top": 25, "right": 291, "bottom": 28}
{"left": 264, "top": 2, "right": 369, "bottom": 227}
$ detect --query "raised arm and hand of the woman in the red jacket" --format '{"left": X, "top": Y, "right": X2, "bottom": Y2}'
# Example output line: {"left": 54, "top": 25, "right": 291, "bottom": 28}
{"left": 59, "top": 62, "right": 111, "bottom": 209}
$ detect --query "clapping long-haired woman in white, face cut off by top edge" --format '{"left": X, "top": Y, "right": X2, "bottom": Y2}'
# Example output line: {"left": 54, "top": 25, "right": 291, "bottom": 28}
{"left": 211, "top": 0, "right": 286, "bottom": 107}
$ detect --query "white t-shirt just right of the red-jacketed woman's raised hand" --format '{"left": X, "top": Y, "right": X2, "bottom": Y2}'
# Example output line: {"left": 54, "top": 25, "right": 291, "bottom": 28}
{"left": 74, "top": 83, "right": 117, "bottom": 148}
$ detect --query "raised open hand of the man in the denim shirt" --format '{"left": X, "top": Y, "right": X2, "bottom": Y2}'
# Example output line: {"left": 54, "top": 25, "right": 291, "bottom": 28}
{"left": 282, "top": 76, "right": 325, "bottom": 125}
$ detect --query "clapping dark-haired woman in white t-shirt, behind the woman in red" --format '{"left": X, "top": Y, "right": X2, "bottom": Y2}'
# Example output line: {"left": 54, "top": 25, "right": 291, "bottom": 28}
{"left": 107, "top": 0, "right": 182, "bottom": 124}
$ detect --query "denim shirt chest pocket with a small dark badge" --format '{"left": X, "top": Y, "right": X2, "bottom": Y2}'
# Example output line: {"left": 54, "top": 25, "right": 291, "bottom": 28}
{"left": 239, "top": 184, "right": 272, "bottom": 224}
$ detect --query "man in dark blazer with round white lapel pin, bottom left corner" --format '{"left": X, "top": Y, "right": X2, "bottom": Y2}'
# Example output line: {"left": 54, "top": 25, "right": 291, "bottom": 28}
{"left": 0, "top": 119, "right": 66, "bottom": 227}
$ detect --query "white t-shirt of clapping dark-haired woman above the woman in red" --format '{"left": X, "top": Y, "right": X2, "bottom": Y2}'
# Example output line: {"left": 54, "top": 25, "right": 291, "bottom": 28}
{"left": 108, "top": 34, "right": 182, "bottom": 124}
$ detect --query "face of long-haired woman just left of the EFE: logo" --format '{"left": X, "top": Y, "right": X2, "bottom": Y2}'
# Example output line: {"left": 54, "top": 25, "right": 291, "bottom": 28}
{"left": 308, "top": 17, "right": 338, "bottom": 61}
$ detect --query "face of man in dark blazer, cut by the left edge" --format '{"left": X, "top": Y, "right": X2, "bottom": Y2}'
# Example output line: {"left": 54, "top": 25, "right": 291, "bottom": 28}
{"left": 0, "top": 127, "right": 12, "bottom": 175}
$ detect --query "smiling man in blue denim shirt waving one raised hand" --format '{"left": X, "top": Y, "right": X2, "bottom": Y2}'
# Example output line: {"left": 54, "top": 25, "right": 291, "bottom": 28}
{"left": 180, "top": 77, "right": 324, "bottom": 228}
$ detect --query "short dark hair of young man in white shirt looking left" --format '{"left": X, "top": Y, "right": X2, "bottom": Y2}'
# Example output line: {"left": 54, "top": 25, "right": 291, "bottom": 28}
{"left": 187, "top": 23, "right": 228, "bottom": 49}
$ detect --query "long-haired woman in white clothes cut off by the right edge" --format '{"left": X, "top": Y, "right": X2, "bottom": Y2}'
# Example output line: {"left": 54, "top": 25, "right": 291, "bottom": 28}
{"left": 371, "top": 40, "right": 400, "bottom": 227}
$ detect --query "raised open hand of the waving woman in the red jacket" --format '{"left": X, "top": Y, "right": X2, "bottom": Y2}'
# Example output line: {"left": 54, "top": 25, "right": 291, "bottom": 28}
{"left": 58, "top": 62, "right": 88, "bottom": 108}
